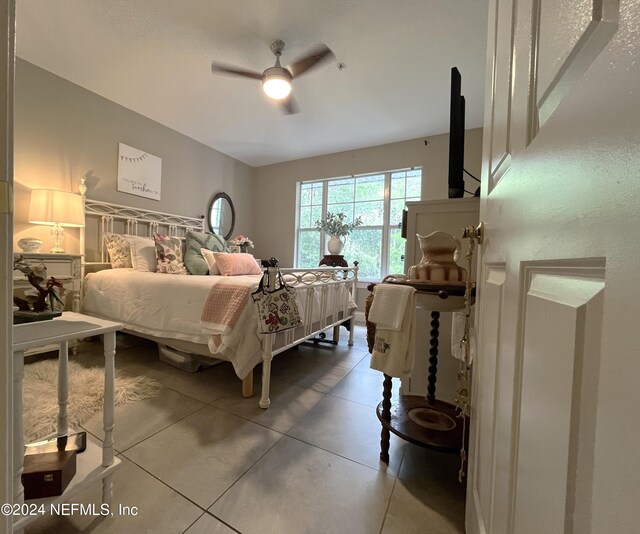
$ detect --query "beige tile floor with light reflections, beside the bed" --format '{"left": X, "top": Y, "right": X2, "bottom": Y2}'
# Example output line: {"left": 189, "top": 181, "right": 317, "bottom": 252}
{"left": 26, "top": 327, "right": 464, "bottom": 534}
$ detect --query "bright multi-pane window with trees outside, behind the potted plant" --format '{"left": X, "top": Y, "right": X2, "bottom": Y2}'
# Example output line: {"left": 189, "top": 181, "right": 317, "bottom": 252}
{"left": 296, "top": 169, "right": 422, "bottom": 280}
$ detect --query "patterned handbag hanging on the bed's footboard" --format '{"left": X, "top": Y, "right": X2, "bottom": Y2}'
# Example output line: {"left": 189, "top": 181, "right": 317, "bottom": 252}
{"left": 251, "top": 269, "right": 302, "bottom": 334}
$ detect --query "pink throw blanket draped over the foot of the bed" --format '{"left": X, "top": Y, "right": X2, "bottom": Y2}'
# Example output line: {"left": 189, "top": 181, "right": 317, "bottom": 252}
{"left": 200, "top": 278, "right": 253, "bottom": 341}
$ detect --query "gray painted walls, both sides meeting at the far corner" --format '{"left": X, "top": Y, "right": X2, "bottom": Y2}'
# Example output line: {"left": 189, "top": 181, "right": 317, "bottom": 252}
{"left": 14, "top": 59, "right": 482, "bottom": 278}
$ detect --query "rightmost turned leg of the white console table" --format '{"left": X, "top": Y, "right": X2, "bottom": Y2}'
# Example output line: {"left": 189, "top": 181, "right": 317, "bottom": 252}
{"left": 102, "top": 332, "right": 116, "bottom": 503}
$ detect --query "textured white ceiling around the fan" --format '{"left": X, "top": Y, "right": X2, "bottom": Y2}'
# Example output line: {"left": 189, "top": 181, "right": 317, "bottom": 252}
{"left": 16, "top": 0, "right": 487, "bottom": 166}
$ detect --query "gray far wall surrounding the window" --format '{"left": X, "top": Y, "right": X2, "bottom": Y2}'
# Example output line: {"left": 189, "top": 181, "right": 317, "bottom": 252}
{"left": 251, "top": 128, "right": 482, "bottom": 266}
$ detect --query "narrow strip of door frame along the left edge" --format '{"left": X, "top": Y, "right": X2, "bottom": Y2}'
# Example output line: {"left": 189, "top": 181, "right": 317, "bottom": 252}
{"left": 0, "top": 0, "right": 15, "bottom": 534}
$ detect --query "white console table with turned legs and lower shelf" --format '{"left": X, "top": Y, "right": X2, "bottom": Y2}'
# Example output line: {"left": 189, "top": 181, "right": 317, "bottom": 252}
{"left": 13, "top": 312, "right": 123, "bottom": 531}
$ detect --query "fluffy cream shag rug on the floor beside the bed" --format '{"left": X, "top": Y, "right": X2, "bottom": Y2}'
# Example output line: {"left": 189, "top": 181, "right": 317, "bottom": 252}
{"left": 23, "top": 360, "right": 160, "bottom": 443}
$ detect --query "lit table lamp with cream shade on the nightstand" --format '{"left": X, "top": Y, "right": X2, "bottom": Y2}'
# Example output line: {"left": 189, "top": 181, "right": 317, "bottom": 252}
{"left": 29, "top": 189, "right": 84, "bottom": 254}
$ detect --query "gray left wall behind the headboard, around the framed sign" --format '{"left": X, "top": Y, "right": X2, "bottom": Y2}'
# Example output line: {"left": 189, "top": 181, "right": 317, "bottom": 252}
{"left": 14, "top": 59, "right": 255, "bottom": 252}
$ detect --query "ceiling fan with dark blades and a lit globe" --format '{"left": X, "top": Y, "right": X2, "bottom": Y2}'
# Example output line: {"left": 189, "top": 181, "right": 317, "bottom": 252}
{"left": 211, "top": 39, "right": 334, "bottom": 114}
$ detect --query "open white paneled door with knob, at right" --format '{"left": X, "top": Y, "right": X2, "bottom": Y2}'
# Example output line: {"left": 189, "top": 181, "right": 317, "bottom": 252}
{"left": 466, "top": 0, "right": 640, "bottom": 534}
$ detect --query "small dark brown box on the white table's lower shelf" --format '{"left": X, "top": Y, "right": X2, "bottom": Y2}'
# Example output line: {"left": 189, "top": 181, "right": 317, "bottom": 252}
{"left": 22, "top": 451, "right": 76, "bottom": 500}
